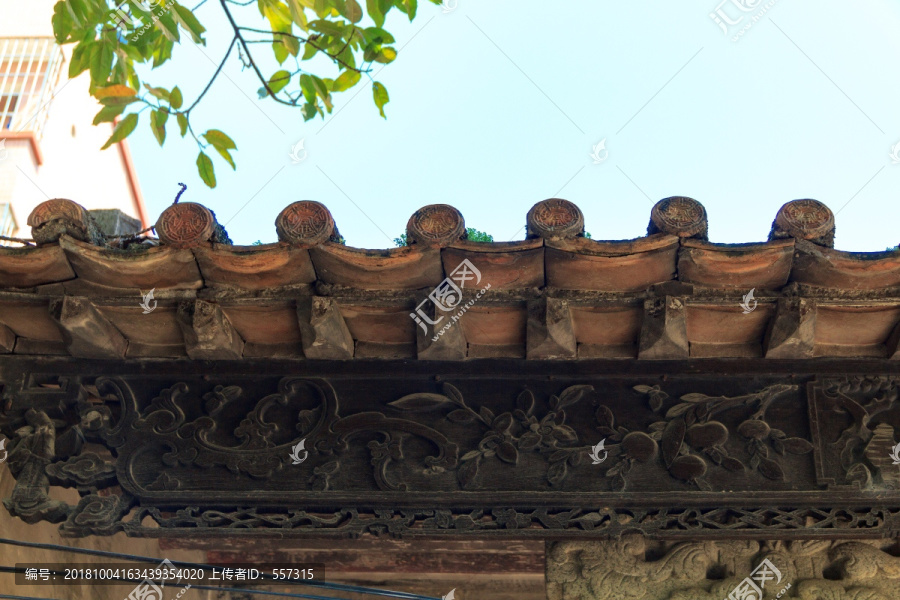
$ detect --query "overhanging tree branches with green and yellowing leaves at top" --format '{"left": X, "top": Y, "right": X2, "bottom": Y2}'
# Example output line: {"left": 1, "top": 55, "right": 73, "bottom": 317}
{"left": 52, "top": 0, "right": 441, "bottom": 188}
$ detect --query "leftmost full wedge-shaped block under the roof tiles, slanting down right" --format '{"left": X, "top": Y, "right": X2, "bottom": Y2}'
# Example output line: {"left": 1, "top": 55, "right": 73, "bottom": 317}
{"left": 50, "top": 296, "right": 128, "bottom": 359}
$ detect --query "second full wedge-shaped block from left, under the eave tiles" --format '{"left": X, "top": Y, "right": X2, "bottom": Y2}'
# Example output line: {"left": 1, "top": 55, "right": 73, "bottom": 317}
{"left": 178, "top": 300, "right": 244, "bottom": 360}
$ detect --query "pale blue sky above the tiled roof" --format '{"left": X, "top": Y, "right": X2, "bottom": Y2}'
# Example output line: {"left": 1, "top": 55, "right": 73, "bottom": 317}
{"left": 129, "top": 0, "right": 900, "bottom": 251}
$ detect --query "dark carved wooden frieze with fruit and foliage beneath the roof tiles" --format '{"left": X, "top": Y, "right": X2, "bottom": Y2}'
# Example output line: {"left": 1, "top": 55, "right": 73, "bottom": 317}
{"left": 0, "top": 356, "right": 900, "bottom": 539}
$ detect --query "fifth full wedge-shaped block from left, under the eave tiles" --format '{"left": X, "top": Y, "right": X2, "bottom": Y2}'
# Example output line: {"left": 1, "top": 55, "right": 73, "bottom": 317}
{"left": 526, "top": 298, "right": 578, "bottom": 359}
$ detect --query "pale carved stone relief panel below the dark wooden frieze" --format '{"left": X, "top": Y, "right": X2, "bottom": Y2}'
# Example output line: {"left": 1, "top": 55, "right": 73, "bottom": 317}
{"left": 547, "top": 533, "right": 900, "bottom": 600}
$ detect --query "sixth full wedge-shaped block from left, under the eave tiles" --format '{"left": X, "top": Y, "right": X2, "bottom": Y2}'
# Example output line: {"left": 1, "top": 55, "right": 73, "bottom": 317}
{"left": 638, "top": 296, "right": 690, "bottom": 359}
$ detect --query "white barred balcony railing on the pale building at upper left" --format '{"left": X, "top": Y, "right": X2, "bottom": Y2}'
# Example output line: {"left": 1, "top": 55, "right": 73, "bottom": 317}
{"left": 0, "top": 37, "right": 65, "bottom": 139}
